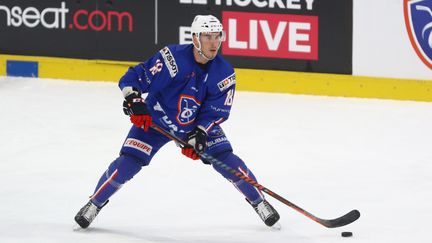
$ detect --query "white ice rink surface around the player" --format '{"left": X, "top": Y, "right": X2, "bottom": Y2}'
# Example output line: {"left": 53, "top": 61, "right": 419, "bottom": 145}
{"left": 0, "top": 77, "right": 432, "bottom": 243}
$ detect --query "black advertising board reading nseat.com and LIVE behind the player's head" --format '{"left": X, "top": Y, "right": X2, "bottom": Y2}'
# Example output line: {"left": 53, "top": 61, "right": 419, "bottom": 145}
{"left": 0, "top": 0, "right": 353, "bottom": 74}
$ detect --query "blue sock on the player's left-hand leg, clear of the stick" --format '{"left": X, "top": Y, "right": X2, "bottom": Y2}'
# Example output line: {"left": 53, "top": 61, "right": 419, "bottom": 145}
{"left": 91, "top": 154, "right": 141, "bottom": 207}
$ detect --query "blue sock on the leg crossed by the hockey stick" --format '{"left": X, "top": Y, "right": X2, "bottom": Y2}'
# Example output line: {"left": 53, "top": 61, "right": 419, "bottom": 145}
{"left": 213, "top": 151, "right": 264, "bottom": 204}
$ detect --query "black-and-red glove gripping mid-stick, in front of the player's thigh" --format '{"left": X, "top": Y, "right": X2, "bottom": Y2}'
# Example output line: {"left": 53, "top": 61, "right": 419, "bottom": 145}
{"left": 182, "top": 126, "right": 209, "bottom": 164}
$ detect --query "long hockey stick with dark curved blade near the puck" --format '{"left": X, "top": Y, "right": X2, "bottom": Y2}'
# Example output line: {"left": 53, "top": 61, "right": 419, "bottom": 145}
{"left": 151, "top": 123, "right": 360, "bottom": 228}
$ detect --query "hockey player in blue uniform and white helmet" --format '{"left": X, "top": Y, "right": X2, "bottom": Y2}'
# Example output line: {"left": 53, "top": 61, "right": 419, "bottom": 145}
{"left": 75, "top": 15, "right": 279, "bottom": 228}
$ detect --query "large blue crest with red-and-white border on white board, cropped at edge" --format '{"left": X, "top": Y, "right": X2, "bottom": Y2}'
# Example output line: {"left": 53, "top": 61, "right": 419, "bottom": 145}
{"left": 404, "top": 0, "right": 432, "bottom": 69}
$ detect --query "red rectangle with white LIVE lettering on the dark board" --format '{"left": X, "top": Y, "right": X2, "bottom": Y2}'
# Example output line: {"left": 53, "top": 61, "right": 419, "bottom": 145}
{"left": 222, "top": 11, "right": 318, "bottom": 60}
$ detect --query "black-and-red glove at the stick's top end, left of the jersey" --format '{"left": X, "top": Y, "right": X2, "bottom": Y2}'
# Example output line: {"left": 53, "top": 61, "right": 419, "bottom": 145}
{"left": 123, "top": 92, "right": 152, "bottom": 132}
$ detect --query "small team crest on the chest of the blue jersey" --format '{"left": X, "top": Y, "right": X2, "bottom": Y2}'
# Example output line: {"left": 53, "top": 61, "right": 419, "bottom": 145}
{"left": 177, "top": 95, "right": 201, "bottom": 126}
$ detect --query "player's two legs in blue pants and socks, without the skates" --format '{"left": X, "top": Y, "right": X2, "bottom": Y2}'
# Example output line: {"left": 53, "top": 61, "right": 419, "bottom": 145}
{"left": 91, "top": 125, "right": 263, "bottom": 206}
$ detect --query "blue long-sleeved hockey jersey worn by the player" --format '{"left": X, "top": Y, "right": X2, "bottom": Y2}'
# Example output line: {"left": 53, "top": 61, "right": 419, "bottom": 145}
{"left": 119, "top": 44, "right": 235, "bottom": 134}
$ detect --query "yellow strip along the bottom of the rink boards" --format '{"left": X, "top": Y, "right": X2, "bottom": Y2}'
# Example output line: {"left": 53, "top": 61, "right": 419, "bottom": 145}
{"left": 0, "top": 55, "right": 432, "bottom": 101}
